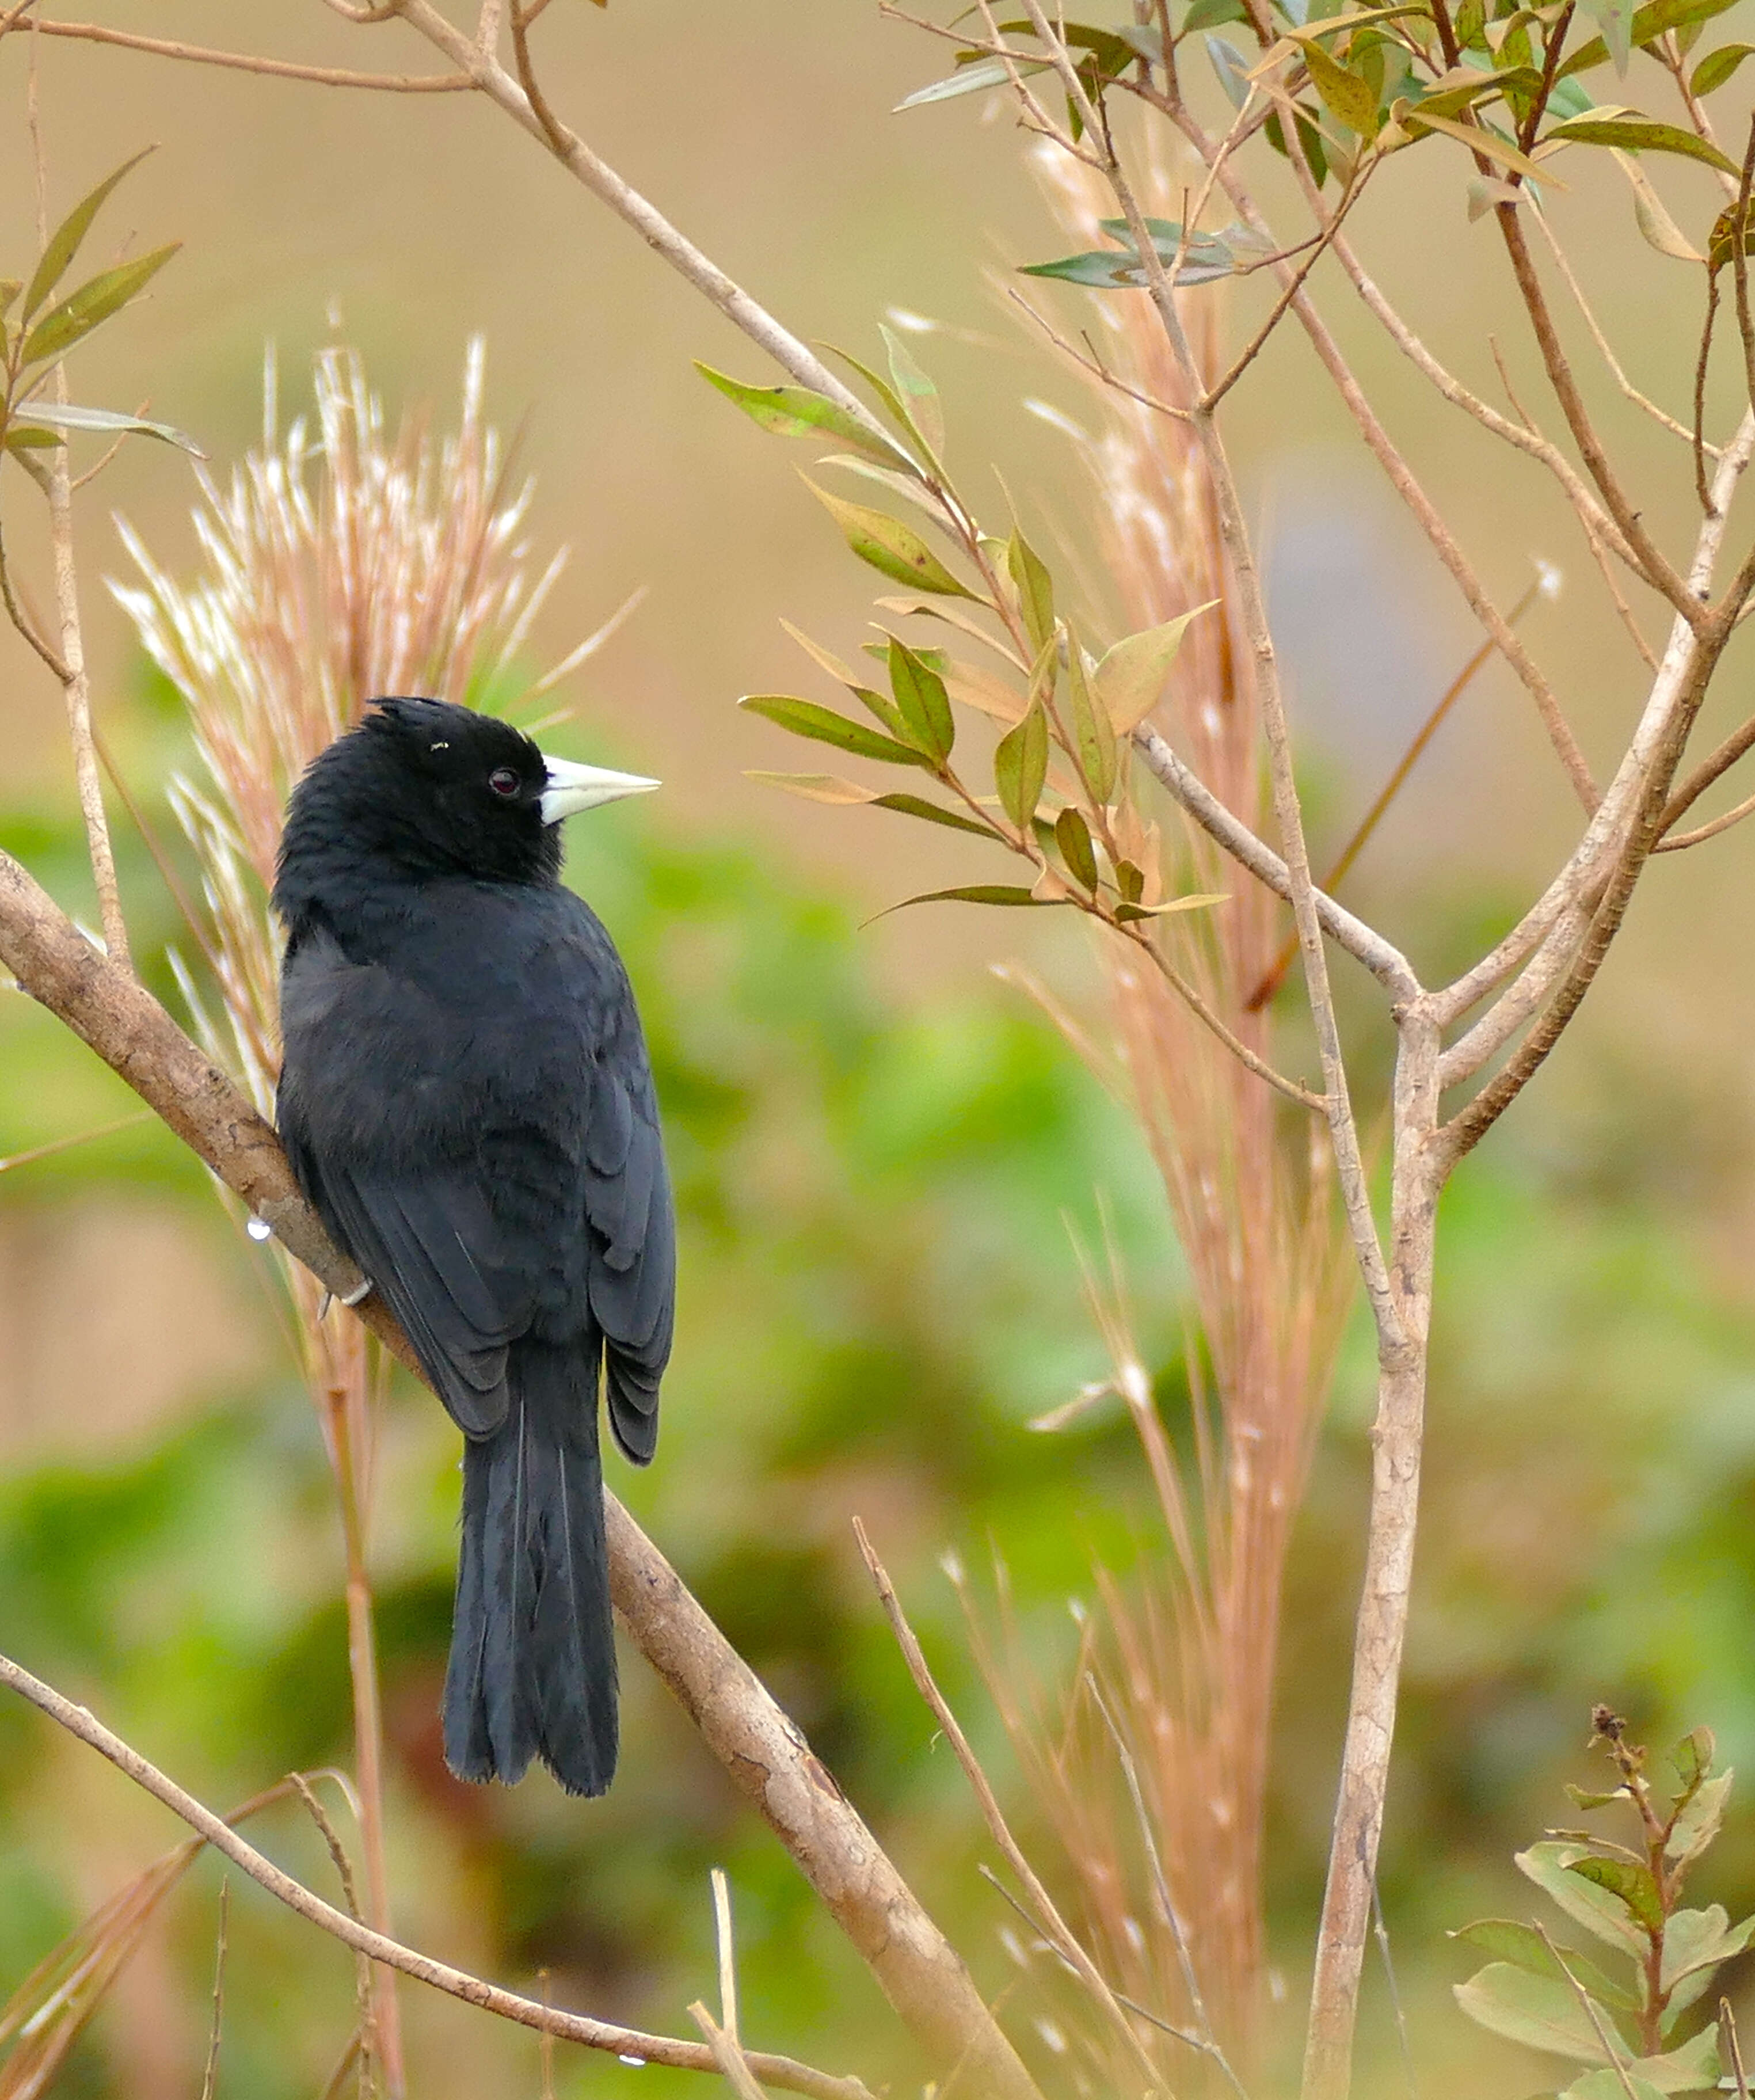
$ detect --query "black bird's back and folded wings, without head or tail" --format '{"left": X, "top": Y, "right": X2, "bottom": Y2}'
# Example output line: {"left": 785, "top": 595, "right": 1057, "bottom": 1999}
{"left": 279, "top": 878, "right": 674, "bottom": 1459}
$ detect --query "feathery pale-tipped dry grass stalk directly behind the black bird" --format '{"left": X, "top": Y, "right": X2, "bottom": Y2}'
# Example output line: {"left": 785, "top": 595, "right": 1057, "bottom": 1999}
{"left": 116, "top": 343, "right": 630, "bottom": 2096}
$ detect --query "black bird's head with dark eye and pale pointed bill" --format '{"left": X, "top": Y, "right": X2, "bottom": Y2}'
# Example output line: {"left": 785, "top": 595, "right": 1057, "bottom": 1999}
{"left": 275, "top": 699, "right": 657, "bottom": 914}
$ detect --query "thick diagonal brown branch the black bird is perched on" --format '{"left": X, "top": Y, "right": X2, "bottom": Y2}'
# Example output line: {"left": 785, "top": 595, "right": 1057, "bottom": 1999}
{"left": 0, "top": 853, "right": 1039, "bottom": 2100}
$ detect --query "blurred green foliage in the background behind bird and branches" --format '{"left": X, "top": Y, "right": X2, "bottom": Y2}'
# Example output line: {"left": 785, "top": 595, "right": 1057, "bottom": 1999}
{"left": 0, "top": 710, "right": 1755, "bottom": 2100}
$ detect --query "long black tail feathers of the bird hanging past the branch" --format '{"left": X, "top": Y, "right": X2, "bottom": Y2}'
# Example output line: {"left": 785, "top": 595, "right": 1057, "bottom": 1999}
{"left": 445, "top": 1340, "right": 615, "bottom": 1793}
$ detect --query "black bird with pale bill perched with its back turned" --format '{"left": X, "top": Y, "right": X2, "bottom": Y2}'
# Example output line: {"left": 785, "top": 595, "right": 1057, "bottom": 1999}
{"left": 275, "top": 699, "right": 676, "bottom": 1793}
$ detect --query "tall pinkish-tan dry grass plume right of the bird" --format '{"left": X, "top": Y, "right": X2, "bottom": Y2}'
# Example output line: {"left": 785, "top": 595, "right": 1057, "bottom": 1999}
{"left": 991, "top": 153, "right": 1350, "bottom": 2071}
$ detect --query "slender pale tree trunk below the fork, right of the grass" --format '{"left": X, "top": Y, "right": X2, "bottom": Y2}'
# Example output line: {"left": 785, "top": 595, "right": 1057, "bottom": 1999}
{"left": 1304, "top": 1002, "right": 1449, "bottom": 2100}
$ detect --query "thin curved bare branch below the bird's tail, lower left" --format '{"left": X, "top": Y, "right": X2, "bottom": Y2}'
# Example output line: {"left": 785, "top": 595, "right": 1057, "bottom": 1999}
{"left": 0, "top": 1655, "right": 871, "bottom": 2100}
